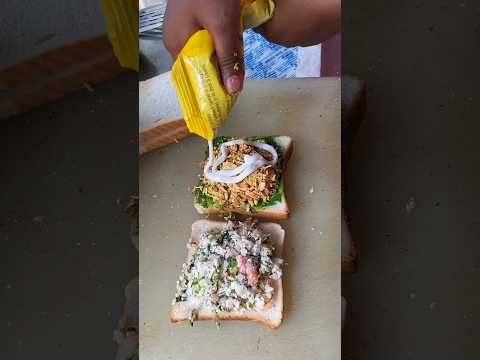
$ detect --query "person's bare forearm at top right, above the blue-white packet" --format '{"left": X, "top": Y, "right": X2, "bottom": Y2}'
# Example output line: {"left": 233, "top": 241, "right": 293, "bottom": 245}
{"left": 254, "top": 0, "right": 341, "bottom": 47}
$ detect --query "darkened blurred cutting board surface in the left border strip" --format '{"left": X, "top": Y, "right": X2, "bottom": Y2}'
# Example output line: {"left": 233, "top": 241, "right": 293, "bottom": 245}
{"left": 0, "top": 74, "right": 138, "bottom": 360}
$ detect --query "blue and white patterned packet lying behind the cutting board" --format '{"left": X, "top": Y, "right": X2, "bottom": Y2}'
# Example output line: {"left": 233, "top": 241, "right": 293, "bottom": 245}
{"left": 243, "top": 29, "right": 321, "bottom": 79}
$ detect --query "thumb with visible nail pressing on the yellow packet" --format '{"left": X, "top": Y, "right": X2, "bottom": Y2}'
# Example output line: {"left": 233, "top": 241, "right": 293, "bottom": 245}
{"left": 212, "top": 27, "right": 245, "bottom": 95}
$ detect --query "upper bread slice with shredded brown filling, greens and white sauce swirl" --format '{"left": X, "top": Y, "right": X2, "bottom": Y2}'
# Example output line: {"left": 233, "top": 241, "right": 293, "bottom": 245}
{"left": 194, "top": 136, "right": 293, "bottom": 219}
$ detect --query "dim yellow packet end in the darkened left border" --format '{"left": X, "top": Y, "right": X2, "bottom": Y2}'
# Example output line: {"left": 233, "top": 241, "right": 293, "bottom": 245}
{"left": 101, "top": 0, "right": 139, "bottom": 71}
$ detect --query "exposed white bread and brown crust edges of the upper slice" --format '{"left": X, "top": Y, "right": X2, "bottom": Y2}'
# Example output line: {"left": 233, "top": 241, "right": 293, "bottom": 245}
{"left": 193, "top": 136, "right": 293, "bottom": 219}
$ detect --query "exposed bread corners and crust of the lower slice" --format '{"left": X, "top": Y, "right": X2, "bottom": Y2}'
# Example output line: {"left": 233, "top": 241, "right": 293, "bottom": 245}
{"left": 170, "top": 220, "right": 285, "bottom": 329}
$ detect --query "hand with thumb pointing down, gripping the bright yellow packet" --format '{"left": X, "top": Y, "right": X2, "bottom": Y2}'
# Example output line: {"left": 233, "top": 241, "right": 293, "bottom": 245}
{"left": 164, "top": 0, "right": 245, "bottom": 94}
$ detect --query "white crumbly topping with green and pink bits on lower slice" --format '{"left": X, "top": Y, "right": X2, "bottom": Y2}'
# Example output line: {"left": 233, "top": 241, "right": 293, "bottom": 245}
{"left": 174, "top": 221, "right": 283, "bottom": 312}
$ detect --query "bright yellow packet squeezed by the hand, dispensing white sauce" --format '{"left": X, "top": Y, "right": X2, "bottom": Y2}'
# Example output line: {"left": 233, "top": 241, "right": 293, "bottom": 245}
{"left": 172, "top": 0, "right": 275, "bottom": 140}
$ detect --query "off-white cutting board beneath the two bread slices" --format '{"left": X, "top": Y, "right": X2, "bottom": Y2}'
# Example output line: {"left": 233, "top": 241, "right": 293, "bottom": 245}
{"left": 140, "top": 78, "right": 341, "bottom": 360}
